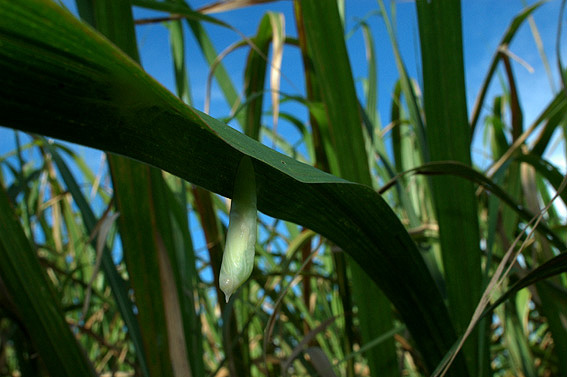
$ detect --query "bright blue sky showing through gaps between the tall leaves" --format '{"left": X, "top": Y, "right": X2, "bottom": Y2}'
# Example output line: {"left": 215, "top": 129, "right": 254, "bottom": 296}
{"left": 0, "top": 0, "right": 567, "bottom": 251}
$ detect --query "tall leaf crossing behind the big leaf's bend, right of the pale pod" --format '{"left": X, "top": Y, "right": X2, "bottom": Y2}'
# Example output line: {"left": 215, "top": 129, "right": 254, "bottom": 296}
{"left": 302, "top": 1, "right": 398, "bottom": 376}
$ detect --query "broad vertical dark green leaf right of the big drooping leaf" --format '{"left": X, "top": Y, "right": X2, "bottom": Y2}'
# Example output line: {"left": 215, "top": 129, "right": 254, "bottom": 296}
{"left": 417, "top": 0, "right": 488, "bottom": 375}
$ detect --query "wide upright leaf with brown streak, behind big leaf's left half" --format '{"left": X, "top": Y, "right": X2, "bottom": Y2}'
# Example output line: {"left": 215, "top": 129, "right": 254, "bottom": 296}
{"left": 86, "top": 1, "right": 185, "bottom": 376}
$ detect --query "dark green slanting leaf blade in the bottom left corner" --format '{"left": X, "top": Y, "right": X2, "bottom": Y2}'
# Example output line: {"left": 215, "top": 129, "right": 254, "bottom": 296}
{"left": 0, "top": 185, "right": 95, "bottom": 376}
